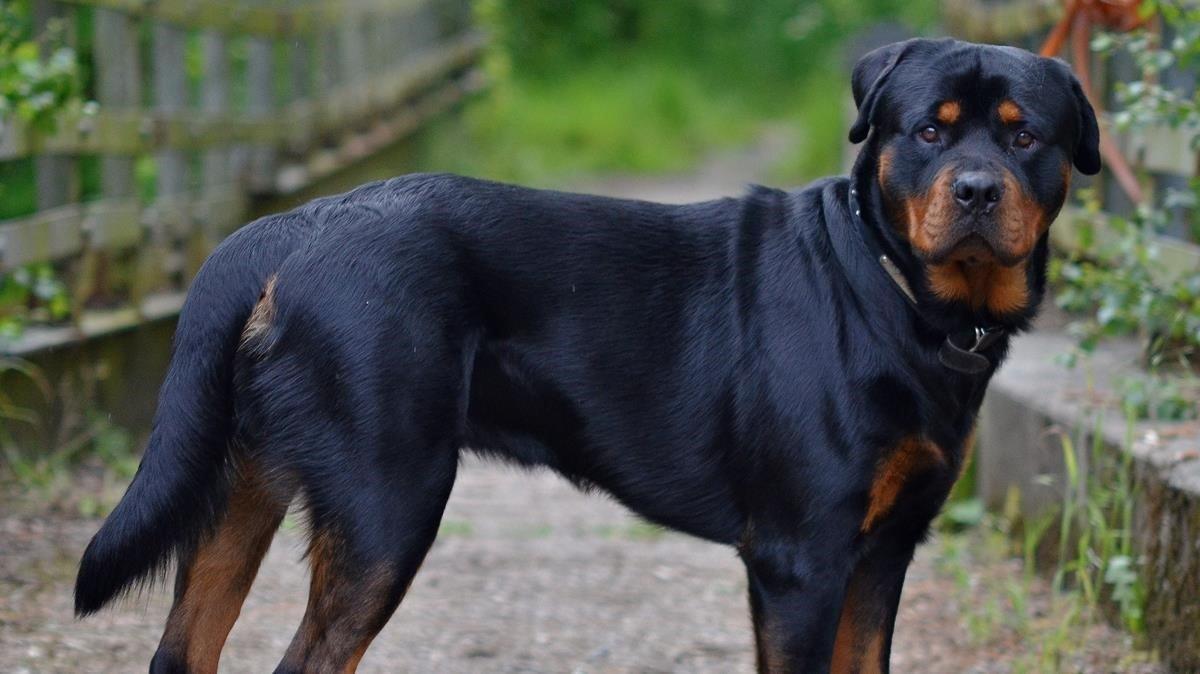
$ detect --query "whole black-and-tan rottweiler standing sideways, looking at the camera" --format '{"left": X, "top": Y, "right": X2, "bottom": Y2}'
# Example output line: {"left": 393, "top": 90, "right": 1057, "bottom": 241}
{"left": 76, "top": 40, "right": 1100, "bottom": 674}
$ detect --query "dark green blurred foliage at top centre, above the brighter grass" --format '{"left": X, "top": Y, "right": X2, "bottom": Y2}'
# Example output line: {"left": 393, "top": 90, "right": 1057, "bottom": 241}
{"left": 476, "top": 0, "right": 936, "bottom": 89}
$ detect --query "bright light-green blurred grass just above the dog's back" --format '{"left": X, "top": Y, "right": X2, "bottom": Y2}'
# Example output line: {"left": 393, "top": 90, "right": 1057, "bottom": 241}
{"left": 427, "top": 55, "right": 847, "bottom": 185}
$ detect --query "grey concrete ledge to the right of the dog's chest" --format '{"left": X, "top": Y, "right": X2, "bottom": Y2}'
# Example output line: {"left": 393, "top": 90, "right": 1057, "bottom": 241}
{"left": 977, "top": 330, "right": 1200, "bottom": 672}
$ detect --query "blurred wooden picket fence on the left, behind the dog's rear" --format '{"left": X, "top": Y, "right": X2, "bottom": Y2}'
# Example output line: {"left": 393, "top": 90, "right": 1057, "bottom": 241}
{"left": 0, "top": 0, "right": 482, "bottom": 354}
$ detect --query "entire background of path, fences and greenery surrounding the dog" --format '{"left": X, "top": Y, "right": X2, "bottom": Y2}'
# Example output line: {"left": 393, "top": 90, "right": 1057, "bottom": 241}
{"left": 0, "top": 0, "right": 1200, "bottom": 673}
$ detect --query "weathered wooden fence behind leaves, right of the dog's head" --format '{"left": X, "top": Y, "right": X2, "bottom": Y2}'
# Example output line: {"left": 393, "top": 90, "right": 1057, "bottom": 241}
{"left": 942, "top": 0, "right": 1200, "bottom": 255}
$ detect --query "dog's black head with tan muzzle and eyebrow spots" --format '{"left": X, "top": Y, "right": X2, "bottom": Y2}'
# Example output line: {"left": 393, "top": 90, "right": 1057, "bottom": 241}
{"left": 850, "top": 40, "right": 1100, "bottom": 313}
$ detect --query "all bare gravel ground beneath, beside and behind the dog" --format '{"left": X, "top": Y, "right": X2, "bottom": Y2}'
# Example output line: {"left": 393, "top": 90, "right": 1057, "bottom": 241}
{"left": 0, "top": 137, "right": 1160, "bottom": 674}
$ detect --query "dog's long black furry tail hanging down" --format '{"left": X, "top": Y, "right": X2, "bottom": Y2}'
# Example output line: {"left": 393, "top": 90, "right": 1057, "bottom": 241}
{"left": 74, "top": 216, "right": 301, "bottom": 616}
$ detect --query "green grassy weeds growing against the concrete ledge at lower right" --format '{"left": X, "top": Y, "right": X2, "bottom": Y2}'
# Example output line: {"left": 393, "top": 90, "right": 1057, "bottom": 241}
{"left": 938, "top": 403, "right": 1147, "bottom": 652}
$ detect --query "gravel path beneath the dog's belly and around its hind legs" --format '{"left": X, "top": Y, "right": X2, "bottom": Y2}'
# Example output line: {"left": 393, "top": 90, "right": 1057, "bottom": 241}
{"left": 0, "top": 461, "right": 752, "bottom": 673}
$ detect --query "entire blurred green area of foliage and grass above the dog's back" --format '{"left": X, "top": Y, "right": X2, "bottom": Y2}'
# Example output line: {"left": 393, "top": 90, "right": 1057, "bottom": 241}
{"left": 433, "top": 0, "right": 936, "bottom": 185}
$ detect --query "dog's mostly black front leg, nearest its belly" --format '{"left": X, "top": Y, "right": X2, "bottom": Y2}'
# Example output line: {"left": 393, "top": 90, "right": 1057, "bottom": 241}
{"left": 742, "top": 538, "right": 852, "bottom": 674}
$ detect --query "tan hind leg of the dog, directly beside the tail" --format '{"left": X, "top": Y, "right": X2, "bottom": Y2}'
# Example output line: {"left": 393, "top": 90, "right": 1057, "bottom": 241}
{"left": 150, "top": 455, "right": 288, "bottom": 674}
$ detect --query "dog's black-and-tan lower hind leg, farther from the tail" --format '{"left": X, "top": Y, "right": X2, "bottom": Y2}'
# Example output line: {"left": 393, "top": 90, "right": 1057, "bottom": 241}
{"left": 276, "top": 446, "right": 458, "bottom": 674}
